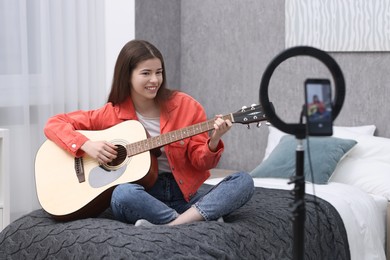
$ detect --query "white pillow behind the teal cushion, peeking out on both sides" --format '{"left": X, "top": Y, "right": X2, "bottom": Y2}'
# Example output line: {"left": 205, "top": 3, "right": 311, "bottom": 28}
{"left": 263, "top": 125, "right": 376, "bottom": 161}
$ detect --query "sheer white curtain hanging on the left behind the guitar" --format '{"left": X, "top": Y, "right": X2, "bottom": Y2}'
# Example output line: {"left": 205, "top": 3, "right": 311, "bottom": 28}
{"left": 0, "top": 0, "right": 107, "bottom": 221}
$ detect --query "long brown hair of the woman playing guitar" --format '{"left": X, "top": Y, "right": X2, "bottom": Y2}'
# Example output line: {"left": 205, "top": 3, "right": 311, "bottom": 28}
{"left": 107, "top": 40, "right": 173, "bottom": 105}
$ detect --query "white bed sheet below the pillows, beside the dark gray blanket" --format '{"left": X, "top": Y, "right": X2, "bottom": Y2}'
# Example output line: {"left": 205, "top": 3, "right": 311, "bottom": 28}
{"left": 206, "top": 178, "right": 387, "bottom": 260}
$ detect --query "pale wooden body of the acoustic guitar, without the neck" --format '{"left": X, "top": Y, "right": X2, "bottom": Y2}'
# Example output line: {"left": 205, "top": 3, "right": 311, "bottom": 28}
{"left": 35, "top": 120, "right": 157, "bottom": 220}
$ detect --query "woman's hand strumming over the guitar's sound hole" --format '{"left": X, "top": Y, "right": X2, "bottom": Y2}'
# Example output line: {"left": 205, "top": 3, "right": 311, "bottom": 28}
{"left": 81, "top": 140, "right": 117, "bottom": 164}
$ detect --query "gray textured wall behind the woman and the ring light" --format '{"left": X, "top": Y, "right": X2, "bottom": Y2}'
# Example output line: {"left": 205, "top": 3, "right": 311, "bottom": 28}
{"left": 136, "top": 0, "right": 390, "bottom": 171}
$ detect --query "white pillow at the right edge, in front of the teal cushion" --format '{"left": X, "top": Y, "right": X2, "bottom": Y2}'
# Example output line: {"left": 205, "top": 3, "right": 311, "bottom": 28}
{"left": 329, "top": 135, "right": 390, "bottom": 200}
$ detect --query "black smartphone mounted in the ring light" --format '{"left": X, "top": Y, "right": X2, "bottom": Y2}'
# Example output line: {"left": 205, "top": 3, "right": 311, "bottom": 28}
{"left": 305, "top": 79, "right": 333, "bottom": 136}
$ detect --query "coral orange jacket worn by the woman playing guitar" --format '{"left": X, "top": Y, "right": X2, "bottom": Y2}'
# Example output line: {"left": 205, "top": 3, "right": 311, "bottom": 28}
{"left": 44, "top": 92, "right": 224, "bottom": 201}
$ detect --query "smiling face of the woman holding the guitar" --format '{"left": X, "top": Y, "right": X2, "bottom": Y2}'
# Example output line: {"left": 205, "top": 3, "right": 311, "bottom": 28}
{"left": 130, "top": 58, "right": 164, "bottom": 101}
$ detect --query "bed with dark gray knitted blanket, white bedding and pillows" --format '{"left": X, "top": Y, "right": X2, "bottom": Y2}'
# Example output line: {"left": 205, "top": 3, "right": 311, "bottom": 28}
{"left": 0, "top": 126, "right": 390, "bottom": 259}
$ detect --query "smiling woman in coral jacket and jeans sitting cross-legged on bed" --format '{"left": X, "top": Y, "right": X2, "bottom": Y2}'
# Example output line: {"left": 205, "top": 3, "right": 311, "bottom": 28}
{"left": 45, "top": 40, "right": 254, "bottom": 225}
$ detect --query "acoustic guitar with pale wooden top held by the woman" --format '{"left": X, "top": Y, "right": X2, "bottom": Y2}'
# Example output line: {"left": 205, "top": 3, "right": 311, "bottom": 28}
{"left": 35, "top": 105, "right": 266, "bottom": 221}
